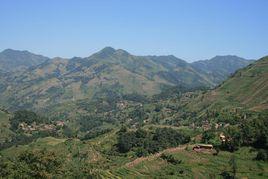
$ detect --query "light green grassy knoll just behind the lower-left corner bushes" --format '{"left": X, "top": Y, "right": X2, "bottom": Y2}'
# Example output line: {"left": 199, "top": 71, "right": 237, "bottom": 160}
{"left": 0, "top": 137, "right": 105, "bottom": 176}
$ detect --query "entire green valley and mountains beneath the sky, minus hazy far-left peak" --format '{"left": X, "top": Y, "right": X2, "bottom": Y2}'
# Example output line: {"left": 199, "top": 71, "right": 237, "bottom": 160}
{"left": 0, "top": 47, "right": 268, "bottom": 178}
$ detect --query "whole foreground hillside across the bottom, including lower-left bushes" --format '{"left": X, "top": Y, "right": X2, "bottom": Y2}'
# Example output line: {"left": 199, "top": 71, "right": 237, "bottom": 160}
{"left": 0, "top": 126, "right": 268, "bottom": 178}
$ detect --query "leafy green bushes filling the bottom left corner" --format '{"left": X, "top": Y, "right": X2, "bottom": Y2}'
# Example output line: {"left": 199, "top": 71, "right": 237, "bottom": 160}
{"left": 0, "top": 150, "right": 64, "bottom": 178}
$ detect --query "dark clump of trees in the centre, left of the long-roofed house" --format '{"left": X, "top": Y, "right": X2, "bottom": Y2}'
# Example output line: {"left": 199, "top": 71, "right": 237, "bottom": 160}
{"left": 116, "top": 128, "right": 190, "bottom": 157}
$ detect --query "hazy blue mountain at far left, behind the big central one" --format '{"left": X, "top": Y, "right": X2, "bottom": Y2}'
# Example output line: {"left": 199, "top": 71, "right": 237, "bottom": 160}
{"left": 0, "top": 49, "right": 48, "bottom": 72}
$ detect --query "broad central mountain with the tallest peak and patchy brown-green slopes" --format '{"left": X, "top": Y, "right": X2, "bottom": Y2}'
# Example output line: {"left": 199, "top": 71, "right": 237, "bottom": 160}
{"left": 0, "top": 47, "right": 254, "bottom": 112}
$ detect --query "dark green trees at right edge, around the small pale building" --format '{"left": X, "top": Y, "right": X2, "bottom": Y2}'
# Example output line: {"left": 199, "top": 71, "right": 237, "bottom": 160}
{"left": 202, "top": 113, "right": 268, "bottom": 161}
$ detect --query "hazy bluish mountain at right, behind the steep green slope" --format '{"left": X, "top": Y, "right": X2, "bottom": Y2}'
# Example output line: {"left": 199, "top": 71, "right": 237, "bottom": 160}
{"left": 191, "top": 55, "right": 254, "bottom": 83}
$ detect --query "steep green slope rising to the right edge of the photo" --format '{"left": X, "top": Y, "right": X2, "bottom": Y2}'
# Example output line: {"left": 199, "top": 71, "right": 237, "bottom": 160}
{"left": 189, "top": 56, "right": 268, "bottom": 111}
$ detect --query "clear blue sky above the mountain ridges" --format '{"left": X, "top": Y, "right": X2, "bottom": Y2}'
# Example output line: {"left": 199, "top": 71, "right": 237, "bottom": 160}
{"left": 0, "top": 0, "right": 268, "bottom": 61}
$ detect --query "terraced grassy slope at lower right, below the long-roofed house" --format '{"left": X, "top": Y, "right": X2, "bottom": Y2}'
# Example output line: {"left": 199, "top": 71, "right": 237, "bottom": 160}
{"left": 112, "top": 148, "right": 268, "bottom": 178}
